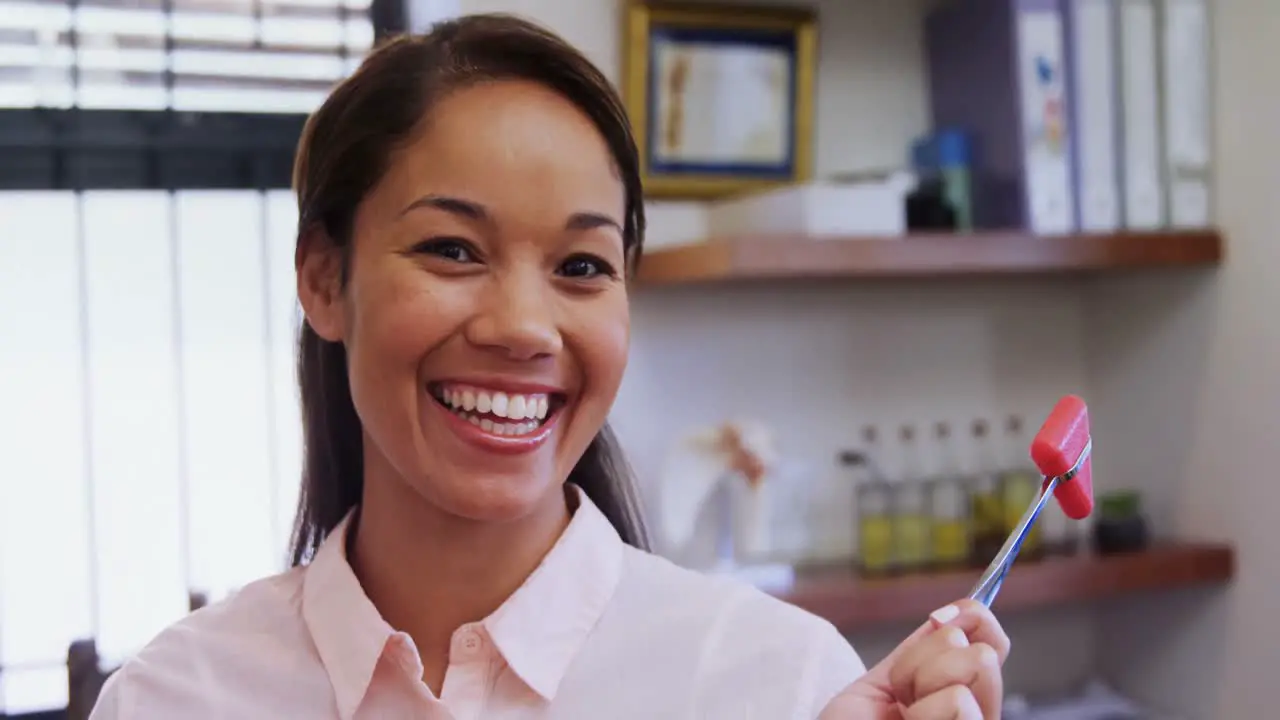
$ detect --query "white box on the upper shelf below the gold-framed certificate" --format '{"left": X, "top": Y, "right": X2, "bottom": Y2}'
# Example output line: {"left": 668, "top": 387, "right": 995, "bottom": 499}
{"left": 707, "top": 173, "right": 914, "bottom": 238}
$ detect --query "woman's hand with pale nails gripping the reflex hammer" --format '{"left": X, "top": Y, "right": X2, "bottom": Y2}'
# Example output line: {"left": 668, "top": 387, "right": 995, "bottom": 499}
{"left": 819, "top": 600, "right": 1009, "bottom": 720}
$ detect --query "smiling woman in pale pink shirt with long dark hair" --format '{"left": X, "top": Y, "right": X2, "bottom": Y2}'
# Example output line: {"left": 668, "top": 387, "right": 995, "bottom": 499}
{"left": 95, "top": 15, "right": 1000, "bottom": 720}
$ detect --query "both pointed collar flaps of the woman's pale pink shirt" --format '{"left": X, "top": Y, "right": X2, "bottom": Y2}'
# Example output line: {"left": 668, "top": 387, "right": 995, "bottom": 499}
{"left": 302, "top": 486, "right": 623, "bottom": 719}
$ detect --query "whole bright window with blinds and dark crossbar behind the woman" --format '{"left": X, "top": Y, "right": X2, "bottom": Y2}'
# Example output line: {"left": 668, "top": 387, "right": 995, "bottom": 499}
{"left": 0, "top": 0, "right": 404, "bottom": 717}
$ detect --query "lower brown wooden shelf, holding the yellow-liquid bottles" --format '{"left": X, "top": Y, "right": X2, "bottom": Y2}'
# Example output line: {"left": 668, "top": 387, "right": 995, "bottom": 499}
{"left": 774, "top": 543, "right": 1235, "bottom": 632}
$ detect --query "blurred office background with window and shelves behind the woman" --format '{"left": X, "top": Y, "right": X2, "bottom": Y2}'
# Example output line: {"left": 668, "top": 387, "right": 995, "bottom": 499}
{"left": 0, "top": 0, "right": 1280, "bottom": 720}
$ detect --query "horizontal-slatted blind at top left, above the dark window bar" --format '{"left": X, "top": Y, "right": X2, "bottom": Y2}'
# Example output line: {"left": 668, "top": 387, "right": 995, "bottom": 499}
{"left": 0, "top": 0, "right": 374, "bottom": 113}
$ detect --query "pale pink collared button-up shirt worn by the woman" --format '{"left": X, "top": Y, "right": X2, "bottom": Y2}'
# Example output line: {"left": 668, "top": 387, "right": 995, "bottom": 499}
{"left": 92, "top": 491, "right": 864, "bottom": 720}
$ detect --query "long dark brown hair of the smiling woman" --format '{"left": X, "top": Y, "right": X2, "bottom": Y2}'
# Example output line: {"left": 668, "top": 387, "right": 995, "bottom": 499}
{"left": 291, "top": 14, "right": 646, "bottom": 565}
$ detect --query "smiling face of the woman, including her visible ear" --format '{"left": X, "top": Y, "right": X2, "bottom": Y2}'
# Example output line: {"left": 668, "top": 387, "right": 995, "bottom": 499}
{"left": 308, "top": 82, "right": 630, "bottom": 520}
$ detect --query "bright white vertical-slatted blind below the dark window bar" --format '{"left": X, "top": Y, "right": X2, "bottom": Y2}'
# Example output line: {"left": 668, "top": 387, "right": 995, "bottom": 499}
{"left": 0, "top": 190, "right": 302, "bottom": 717}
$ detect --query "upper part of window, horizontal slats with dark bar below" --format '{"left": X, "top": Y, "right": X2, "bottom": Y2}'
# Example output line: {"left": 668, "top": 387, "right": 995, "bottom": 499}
{"left": 0, "top": 0, "right": 406, "bottom": 191}
